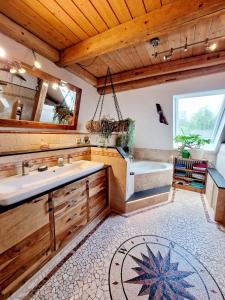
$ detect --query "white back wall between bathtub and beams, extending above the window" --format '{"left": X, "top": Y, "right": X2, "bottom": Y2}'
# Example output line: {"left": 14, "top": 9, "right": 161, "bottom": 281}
{"left": 98, "top": 73, "right": 225, "bottom": 149}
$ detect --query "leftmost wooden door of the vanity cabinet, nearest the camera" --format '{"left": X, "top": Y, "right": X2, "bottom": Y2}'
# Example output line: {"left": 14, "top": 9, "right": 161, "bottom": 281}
{"left": 0, "top": 195, "right": 52, "bottom": 298}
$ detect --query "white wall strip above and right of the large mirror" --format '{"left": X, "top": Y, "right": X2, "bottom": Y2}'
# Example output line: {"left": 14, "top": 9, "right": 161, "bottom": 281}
{"left": 0, "top": 33, "right": 98, "bottom": 130}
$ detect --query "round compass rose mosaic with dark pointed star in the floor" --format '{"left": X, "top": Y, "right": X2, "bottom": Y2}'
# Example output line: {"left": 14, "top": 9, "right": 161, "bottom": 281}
{"left": 109, "top": 235, "right": 224, "bottom": 300}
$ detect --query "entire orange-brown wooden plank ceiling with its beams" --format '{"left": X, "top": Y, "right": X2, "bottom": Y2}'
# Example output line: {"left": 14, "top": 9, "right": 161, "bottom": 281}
{"left": 0, "top": 0, "right": 225, "bottom": 92}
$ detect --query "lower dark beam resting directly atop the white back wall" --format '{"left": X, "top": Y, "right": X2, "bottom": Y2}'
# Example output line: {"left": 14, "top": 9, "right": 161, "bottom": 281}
{"left": 98, "top": 64, "right": 225, "bottom": 94}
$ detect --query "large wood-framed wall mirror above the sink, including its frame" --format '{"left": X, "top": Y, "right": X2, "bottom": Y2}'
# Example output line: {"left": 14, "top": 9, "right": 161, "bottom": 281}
{"left": 0, "top": 62, "right": 81, "bottom": 130}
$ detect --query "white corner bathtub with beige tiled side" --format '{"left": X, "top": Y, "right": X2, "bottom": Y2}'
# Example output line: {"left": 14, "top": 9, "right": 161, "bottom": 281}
{"left": 130, "top": 160, "right": 173, "bottom": 192}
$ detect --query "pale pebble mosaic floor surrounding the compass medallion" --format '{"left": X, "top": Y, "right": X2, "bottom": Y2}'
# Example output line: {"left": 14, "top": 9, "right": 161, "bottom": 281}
{"left": 11, "top": 190, "right": 225, "bottom": 300}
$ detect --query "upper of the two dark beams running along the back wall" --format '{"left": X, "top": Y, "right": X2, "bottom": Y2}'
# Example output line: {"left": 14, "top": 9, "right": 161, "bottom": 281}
{"left": 97, "top": 51, "right": 225, "bottom": 88}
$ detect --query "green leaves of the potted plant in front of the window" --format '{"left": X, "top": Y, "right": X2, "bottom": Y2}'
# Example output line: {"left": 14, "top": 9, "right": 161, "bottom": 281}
{"left": 175, "top": 134, "right": 211, "bottom": 151}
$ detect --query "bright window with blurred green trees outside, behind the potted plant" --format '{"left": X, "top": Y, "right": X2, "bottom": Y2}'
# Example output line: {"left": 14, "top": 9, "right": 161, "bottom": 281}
{"left": 174, "top": 90, "right": 225, "bottom": 149}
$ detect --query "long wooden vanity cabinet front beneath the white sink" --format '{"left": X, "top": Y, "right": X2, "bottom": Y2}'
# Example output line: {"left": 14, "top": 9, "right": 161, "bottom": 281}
{"left": 0, "top": 166, "right": 109, "bottom": 299}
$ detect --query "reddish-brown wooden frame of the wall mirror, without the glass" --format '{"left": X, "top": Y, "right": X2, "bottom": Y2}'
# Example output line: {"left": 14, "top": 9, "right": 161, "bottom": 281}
{"left": 0, "top": 59, "right": 82, "bottom": 130}
